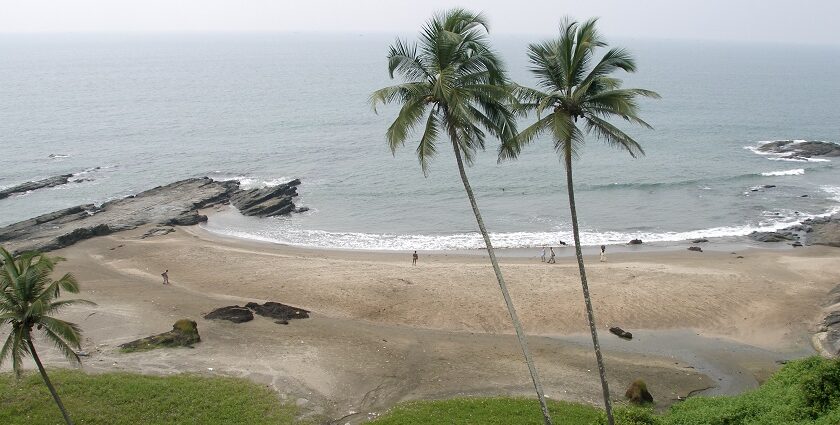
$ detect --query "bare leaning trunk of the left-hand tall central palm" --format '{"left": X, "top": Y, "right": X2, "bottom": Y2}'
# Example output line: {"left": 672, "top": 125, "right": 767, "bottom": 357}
{"left": 452, "top": 142, "right": 552, "bottom": 425}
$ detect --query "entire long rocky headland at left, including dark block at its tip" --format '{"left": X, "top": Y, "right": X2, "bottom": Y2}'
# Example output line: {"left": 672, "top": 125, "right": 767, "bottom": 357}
{"left": 0, "top": 177, "right": 306, "bottom": 252}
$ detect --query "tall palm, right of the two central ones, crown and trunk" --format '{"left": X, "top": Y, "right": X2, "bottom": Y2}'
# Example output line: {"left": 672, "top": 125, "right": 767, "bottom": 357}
{"left": 499, "top": 19, "right": 659, "bottom": 424}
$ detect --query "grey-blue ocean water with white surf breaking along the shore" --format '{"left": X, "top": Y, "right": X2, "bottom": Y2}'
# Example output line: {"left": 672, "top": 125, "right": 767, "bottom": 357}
{"left": 0, "top": 34, "right": 840, "bottom": 250}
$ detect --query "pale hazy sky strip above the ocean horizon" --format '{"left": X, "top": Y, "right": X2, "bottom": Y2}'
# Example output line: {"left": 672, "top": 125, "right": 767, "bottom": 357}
{"left": 0, "top": 0, "right": 840, "bottom": 45}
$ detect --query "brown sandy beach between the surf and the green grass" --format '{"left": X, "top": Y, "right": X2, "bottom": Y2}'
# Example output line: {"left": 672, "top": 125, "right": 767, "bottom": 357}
{"left": 4, "top": 217, "right": 840, "bottom": 423}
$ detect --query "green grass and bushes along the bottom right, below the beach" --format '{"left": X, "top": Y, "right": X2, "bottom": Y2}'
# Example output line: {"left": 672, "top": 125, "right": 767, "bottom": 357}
{"left": 373, "top": 357, "right": 840, "bottom": 425}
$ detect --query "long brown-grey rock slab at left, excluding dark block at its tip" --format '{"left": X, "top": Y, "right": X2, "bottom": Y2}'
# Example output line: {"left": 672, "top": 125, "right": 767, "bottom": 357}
{"left": 0, "top": 177, "right": 239, "bottom": 251}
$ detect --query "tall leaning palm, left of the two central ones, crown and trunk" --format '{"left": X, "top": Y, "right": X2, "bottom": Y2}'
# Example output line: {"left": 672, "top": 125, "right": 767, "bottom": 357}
{"left": 370, "top": 9, "right": 551, "bottom": 424}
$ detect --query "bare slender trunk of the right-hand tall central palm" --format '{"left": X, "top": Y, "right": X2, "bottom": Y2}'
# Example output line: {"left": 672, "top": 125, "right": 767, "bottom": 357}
{"left": 565, "top": 147, "right": 615, "bottom": 425}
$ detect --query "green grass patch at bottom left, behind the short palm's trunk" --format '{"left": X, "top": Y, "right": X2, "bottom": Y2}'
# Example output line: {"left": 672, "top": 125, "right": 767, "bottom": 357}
{"left": 0, "top": 369, "right": 297, "bottom": 425}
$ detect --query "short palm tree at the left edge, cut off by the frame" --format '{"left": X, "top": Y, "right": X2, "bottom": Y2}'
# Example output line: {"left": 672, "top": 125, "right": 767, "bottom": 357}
{"left": 0, "top": 247, "right": 92, "bottom": 425}
